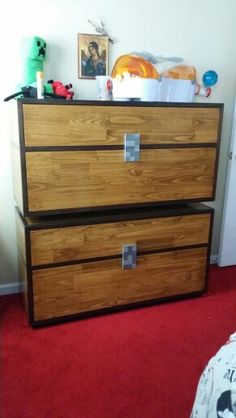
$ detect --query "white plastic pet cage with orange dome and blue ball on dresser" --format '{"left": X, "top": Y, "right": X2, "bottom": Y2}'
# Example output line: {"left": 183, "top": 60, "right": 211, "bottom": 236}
{"left": 111, "top": 51, "right": 218, "bottom": 102}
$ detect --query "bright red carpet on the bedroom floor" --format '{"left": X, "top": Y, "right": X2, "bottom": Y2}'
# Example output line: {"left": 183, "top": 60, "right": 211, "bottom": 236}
{"left": 0, "top": 266, "right": 236, "bottom": 418}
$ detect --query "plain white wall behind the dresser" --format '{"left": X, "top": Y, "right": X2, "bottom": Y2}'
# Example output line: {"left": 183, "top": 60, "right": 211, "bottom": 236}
{"left": 0, "top": 0, "right": 236, "bottom": 283}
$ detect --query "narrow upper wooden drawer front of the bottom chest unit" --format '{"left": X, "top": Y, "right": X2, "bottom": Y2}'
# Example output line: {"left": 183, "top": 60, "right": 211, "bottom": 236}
{"left": 30, "top": 213, "right": 211, "bottom": 266}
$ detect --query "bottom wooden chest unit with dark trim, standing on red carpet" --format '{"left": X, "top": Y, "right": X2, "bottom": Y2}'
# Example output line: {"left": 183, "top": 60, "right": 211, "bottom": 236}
{"left": 16, "top": 204, "right": 213, "bottom": 326}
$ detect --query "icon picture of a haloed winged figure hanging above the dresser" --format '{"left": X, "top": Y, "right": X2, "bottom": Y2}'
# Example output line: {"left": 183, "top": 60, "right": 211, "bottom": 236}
{"left": 78, "top": 33, "right": 109, "bottom": 79}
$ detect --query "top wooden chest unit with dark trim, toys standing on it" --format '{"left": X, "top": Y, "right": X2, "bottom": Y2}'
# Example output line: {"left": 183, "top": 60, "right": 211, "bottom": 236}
{"left": 13, "top": 99, "right": 223, "bottom": 217}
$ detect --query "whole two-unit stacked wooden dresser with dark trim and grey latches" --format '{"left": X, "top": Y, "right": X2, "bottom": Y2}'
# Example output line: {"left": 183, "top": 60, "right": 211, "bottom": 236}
{"left": 12, "top": 100, "right": 223, "bottom": 326}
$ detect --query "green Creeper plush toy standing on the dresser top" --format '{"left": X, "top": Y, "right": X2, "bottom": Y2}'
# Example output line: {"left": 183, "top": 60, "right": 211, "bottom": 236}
{"left": 21, "top": 36, "right": 53, "bottom": 93}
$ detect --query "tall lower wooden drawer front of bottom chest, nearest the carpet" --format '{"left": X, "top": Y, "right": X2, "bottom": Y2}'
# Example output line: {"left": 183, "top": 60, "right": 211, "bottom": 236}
{"left": 33, "top": 248, "right": 207, "bottom": 321}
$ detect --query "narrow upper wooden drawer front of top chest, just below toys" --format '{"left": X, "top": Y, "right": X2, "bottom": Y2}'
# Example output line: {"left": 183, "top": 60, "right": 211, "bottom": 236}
{"left": 23, "top": 104, "right": 220, "bottom": 147}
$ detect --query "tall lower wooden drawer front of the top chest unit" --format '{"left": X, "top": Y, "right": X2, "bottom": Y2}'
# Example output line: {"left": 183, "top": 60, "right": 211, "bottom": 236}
{"left": 26, "top": 147, "right": 216, "bottom": 213}
